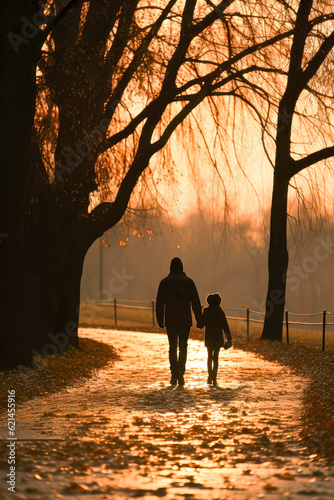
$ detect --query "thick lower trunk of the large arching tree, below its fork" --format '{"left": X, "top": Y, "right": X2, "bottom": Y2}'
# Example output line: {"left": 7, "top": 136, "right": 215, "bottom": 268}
{"left": 29, "top": 208, "right": 89, "bottom": 356}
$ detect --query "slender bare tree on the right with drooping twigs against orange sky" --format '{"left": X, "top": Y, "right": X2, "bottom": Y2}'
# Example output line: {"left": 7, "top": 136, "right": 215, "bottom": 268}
{"left": 156, "top": 0, "right": 334, "bottom": 341}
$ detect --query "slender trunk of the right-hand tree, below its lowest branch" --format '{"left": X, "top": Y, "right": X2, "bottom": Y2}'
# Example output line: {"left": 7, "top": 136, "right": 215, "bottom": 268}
{"left": 261, "top": 170, "right": 289, "bottom": 342}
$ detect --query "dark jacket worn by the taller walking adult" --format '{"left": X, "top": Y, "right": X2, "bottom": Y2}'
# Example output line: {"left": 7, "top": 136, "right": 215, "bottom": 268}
{"left": 156, "top": 271, "right": 202, "bottom": 328}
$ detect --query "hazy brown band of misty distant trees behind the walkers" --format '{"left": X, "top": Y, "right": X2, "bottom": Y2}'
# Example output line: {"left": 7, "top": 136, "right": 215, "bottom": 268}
{"left": 81, "top": 212, "right": 334, "bottom": 313}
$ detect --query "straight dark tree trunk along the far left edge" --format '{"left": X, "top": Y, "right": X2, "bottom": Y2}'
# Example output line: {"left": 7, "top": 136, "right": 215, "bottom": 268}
{"left": 0, "top": 0, "right": 39, "bottom": 368}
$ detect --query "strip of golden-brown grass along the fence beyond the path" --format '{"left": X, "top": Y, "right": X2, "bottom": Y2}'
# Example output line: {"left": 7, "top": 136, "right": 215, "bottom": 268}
{"left": 80, "top": 304, "right": 334, "bottom": 352}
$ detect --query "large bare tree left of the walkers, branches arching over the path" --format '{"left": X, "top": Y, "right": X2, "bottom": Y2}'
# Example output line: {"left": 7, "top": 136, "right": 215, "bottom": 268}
{"left": 2, "top": 0, "right": 298, "bottom": 365}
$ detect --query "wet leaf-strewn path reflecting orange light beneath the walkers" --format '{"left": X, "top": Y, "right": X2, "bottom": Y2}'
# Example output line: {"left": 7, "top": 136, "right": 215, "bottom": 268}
{"left": 0, "top": 329, "right": 334, "bottom": 500}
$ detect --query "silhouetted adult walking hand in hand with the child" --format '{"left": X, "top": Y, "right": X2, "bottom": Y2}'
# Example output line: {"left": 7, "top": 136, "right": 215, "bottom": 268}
{"left": 156, "top": 257, "right": 202, "bottom": 385}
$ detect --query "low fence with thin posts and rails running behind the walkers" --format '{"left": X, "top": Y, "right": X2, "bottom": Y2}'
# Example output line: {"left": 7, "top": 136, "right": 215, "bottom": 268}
{"left": 81, "top": 298, "right": 334, "bottom": 351}
